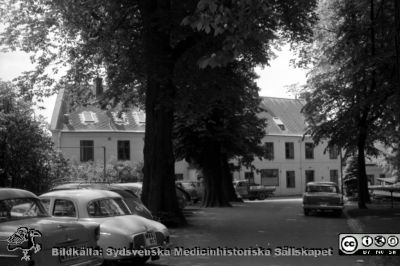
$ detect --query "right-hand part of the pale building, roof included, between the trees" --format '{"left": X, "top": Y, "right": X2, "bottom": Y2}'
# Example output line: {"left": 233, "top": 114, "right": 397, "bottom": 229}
{"left": 234, "top": 97, "right": 342, "bottom": 195}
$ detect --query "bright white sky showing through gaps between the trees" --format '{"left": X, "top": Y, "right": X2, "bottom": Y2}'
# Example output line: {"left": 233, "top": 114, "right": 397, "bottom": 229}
{"left": 0, "top": 45, "right": 306, "bottom": 123}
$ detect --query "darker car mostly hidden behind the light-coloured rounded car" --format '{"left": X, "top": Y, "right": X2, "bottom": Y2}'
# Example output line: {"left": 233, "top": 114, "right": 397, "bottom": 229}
{"left": 51, "top": 182, "right": 153, "bottom": 219}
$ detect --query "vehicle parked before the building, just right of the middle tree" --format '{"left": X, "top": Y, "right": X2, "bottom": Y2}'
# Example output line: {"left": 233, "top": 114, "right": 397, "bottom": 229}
{"left": 233, "top": 180, "right": 276, "bottom": 200}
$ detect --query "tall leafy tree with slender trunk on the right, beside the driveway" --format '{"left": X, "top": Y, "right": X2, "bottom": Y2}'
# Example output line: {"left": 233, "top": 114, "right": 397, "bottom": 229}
{"left": 303, "top": 0, "right": 398, "bottom": 207}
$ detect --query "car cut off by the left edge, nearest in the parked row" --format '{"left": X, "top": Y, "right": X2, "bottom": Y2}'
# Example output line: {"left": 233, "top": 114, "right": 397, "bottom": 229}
{"left": 0, "top": 188, "right": 103, "bottom": 266}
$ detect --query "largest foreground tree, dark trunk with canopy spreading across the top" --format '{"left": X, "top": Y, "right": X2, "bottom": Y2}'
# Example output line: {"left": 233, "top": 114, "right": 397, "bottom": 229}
{"left": 0, "top": 0, "right": 316, "bottom": 216}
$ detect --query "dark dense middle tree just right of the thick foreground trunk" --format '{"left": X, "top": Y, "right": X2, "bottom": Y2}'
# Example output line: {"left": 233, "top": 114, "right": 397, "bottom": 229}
{"left": 174, "top": 62, "right": 266, "bottom": 206}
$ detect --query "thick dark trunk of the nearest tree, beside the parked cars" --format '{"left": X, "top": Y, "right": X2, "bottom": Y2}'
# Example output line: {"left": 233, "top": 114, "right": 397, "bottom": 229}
{"left": 141, "top": 0, "right": 185, "bottom": 225}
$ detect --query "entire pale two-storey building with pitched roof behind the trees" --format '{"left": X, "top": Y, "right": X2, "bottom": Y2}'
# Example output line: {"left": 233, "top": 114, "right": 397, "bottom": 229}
{"left": 50, "top": 91, "right": 342, "bottom": 195}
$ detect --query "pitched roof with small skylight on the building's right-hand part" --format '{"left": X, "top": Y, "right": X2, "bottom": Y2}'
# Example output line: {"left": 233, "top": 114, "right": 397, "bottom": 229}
{"left": 260, "top": 97, "right": 306, "bottom": 136}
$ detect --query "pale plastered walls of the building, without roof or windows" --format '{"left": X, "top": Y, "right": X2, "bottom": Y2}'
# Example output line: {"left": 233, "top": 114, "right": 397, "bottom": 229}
{"left": 53, "top": 132, "right": 341, "bottom": 195}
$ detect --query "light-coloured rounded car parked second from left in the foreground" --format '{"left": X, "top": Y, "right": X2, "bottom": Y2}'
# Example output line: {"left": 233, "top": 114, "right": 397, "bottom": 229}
{"left": 40, "top": 189, "right": 169, "bottom": 264}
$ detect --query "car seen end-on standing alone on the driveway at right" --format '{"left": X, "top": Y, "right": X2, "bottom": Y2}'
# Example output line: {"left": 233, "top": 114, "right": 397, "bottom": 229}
{"left": 303, "top": 182, "right": 343, "bottom": 216}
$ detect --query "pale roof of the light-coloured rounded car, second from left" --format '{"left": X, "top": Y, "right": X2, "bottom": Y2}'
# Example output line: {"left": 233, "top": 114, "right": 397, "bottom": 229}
{"left": 39, "top": 189, "right": 122, "bottom": 201}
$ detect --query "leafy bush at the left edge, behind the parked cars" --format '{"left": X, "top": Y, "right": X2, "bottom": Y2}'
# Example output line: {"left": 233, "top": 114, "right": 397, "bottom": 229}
{"left": 0, "top": 81, "right": 68, "bottom": 193}
